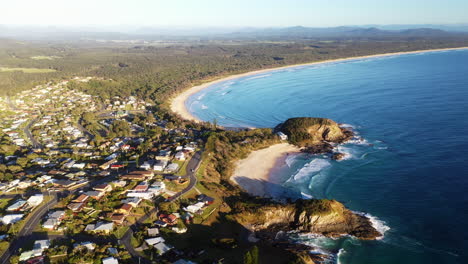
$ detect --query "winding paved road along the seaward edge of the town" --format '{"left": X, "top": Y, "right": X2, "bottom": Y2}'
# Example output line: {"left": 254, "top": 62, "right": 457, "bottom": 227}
{"left": 121, "top": 151, "right": 202, "bottom": 264}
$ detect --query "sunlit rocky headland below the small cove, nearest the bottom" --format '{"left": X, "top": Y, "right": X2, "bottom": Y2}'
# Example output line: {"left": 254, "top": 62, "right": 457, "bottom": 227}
{"left": 235, "top": 199, "right": 382, "bottom": 240}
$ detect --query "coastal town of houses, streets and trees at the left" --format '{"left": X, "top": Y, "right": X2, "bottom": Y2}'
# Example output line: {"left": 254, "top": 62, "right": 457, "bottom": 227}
{"left": 0, "top": 77, "right": 219, "bottom": 264}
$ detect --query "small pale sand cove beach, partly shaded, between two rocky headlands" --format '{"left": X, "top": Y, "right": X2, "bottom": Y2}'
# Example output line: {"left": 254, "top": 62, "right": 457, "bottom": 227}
{"left": 231, "top": 143, "right": 300, "bottom": 196}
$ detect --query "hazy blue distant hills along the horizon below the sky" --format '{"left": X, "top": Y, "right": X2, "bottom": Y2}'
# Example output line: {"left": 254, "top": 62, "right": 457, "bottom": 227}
{"left": 0, "top": 25, "right": 468, "bottom": 40}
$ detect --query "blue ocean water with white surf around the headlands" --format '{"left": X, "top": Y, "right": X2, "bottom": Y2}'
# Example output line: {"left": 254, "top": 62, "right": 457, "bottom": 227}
{"left": 186, "top": 50, "right": 468, "bottom": 264}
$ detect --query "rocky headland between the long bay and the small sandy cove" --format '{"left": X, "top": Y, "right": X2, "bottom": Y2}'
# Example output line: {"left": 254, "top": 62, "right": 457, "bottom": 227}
{"left": 275, "top": 117, "right": 353, "bottom": 154}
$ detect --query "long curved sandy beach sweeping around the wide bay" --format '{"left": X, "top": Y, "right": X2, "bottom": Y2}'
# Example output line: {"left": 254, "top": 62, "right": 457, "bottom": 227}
{"left": 170, "top": 47, "right": 468, "bottom": 123}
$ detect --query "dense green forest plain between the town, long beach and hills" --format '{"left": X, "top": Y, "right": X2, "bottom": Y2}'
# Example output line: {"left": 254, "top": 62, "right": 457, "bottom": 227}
{"left": 0, "top": 36, "right": 468, "bottom": 108}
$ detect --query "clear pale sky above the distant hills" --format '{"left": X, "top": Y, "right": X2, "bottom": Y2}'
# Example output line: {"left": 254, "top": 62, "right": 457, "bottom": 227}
{"left": 0, "top": 0, "right": 468, "bottom": 27}
